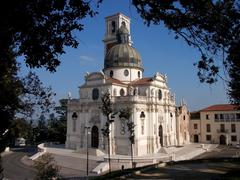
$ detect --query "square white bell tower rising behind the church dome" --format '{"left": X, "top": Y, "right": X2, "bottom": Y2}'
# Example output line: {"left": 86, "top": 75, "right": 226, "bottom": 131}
{"left": 103, "top": 13, "right": 132, "bottom": 57}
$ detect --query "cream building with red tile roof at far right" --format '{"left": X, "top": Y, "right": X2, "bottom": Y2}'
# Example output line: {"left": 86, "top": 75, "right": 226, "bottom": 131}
{"left": 190, "top": 104, "right": 240, "bottom": 145}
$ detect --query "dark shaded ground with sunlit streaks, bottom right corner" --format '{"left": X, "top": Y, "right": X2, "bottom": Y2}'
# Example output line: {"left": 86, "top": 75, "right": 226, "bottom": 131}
{"left": 128, "top": 161, "right": 240, "bottom": 180}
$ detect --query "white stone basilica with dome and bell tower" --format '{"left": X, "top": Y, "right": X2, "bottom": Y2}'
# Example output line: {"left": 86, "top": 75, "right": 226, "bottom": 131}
{"left": 66, "top": 13, "right": 189, "bottom": 156}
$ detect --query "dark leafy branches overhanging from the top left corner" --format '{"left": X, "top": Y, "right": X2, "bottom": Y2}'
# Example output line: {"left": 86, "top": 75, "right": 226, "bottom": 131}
{"left": 0, "top": 0, "right": 95, "bottom": 71}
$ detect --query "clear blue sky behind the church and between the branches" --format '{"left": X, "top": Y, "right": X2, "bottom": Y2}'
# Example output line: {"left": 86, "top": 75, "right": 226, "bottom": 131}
{"left": 19, "top": 0, "right": 228, "bottom": 111}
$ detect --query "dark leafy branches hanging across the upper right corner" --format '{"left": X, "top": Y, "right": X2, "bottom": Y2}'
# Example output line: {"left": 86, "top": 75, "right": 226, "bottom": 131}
{"left": 132, "top": 0, "right": 240, "bottom": 104}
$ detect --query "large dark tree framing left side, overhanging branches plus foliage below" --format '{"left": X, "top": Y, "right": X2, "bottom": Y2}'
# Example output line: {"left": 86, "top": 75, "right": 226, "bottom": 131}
{"left": 0, "top": 0, "right": 96, "bottom": 154}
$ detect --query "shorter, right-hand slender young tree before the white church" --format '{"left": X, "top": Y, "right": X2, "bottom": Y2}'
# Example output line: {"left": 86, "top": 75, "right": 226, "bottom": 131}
{"left": 119, "top": 107, "right": 135, "bottom": 168}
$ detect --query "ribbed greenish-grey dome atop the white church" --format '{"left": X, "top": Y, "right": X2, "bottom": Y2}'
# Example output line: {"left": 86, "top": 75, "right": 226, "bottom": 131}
{"left": 104, "top": 43, "right": 142, "bottom": 69}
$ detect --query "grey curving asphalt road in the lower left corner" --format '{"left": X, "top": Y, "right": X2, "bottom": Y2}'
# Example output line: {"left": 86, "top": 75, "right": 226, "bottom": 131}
{"left": 2, "top": 148, "right": 36, "bottom": 180}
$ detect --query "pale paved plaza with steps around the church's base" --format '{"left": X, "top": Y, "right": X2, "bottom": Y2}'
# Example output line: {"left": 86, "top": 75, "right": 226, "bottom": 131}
{"left": 24, "top": 143, "right": 217, "bottom": 178}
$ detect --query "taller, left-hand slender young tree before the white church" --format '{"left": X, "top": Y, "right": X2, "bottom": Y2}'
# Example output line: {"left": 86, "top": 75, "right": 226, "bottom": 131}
{"left": 100, "top": 92, "right": 116, "bottom": 173}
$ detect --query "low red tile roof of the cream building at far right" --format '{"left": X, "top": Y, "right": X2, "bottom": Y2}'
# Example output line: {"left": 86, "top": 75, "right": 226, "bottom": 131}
{"left": 200, "top": 104, "right": 240, "bottom": 111}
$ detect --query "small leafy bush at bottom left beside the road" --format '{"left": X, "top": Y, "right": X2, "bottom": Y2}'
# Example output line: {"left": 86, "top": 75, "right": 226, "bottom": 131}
{"left": 33, "top": 153, "right": 60, "bottom": 180}
